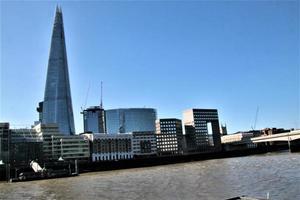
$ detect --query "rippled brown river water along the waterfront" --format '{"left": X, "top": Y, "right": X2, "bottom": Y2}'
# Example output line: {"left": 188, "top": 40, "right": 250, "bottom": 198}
{"left": 0, "top": 152, "right": 300, "bottom": 200}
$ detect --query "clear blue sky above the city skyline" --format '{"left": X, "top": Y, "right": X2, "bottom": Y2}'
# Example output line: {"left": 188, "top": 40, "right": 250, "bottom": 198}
{"left": 0, "top": 0, "right": 300, "bottom": 133}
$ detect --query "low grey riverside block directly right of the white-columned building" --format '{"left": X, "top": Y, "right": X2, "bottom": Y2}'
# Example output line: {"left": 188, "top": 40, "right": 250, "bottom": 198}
{"left": 132, "top": 131, "right": 157, "bottom": 157}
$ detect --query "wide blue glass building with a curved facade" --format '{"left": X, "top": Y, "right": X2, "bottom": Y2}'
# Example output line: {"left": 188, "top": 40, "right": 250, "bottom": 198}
{"left": 105, "top": 108, "right": 156, "bottom": 134}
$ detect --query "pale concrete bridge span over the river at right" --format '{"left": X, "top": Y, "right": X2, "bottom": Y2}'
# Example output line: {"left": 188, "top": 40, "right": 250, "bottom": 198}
{"left": 250, "top": 130, "right": 300, "bottom": 143}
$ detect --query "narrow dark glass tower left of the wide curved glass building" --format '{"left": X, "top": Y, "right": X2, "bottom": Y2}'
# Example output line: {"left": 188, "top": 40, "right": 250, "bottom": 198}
{"left": 82, "top": 106, "right": 106, "bottom": 133}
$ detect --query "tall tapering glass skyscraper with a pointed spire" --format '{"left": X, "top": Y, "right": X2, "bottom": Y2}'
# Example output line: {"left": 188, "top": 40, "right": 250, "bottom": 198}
{"left": 42, "top": 7, "right": 75, "bottom": 135}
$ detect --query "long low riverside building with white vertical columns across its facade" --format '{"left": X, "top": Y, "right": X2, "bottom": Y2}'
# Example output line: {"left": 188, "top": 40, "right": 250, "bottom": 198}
{"left": 83, "top": 133, "right": 133, "bottom": 162}
